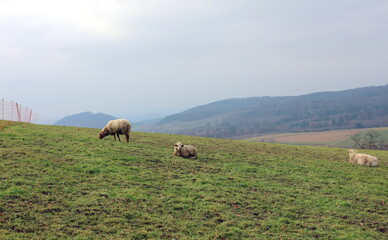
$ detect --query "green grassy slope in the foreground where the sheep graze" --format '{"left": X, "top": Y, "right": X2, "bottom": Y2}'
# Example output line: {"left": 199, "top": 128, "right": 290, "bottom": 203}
{"left": 0, "top": 121, "right": 388, "bottom": 239}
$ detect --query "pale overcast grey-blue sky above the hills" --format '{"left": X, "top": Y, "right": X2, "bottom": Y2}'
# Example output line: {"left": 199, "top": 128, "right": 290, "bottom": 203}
{"left": 0, "top": 0, "right": 388, "bottom": 122}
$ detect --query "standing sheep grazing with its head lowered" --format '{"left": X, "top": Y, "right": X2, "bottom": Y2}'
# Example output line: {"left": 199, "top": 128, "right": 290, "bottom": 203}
{"left": 99, "top": 119, "right": 131, "bottom": 142}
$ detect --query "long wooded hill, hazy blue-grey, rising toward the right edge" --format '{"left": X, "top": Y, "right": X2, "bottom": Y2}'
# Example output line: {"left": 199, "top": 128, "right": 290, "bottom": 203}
{"left": 139, "top": 85, "right": 388, "bottom": 138}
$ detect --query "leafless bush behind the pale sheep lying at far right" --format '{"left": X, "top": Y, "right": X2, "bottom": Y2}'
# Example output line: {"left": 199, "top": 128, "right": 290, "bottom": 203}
{"left": 351, "top": 130, "right": 388, "bottom": 150}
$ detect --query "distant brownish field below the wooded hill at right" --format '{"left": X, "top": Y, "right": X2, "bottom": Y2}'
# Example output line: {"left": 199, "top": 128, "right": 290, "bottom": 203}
{"left": 244, "top": 127, "right": 388, "bottom": 147}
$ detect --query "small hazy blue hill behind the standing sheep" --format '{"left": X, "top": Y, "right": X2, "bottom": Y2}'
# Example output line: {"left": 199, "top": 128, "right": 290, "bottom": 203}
{"left": 54, "top": 112, "right": 116, "bottom": 128}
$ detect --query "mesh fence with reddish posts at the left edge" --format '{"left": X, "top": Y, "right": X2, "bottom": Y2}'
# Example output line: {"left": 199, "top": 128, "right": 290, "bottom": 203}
{"left": 0, "top": 99, "right": 38, "bottom": 123}
